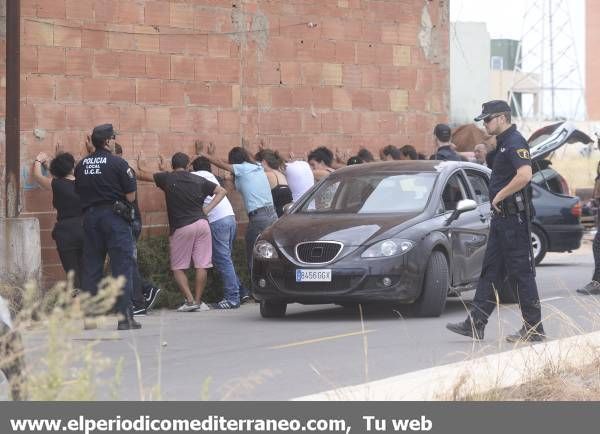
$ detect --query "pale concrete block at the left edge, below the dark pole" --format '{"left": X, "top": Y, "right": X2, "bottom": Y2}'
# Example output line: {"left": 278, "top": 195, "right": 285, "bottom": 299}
{"left": 0, "top": 218, "right": 42, "bottom": 286}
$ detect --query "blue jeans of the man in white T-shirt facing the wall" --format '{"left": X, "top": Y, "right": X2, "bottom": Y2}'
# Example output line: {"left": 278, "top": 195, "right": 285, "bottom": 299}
{"left": 210, "top": 216, "right": 241, "bottom": 305}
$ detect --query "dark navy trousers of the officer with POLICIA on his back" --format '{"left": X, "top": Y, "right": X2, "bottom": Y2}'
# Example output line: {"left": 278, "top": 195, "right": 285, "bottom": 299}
{"left": 83, "top": 207, "right": 135, "bottom": 317}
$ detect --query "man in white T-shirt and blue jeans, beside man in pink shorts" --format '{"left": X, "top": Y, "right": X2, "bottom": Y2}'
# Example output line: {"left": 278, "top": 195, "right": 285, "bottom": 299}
{"left": 192, "top": 157, "right": 241, "bottom": 309}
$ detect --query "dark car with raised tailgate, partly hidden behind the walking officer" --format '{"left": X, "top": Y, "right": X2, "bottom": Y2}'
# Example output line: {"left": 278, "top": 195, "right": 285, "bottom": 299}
{"left": 528, "top": 122, "right": 593, "bottom": 264}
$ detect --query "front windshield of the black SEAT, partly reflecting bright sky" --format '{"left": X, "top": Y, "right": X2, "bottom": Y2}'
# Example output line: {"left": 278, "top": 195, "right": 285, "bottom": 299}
{"left": 296, "top": 172, "right": 437, "bottom": 214}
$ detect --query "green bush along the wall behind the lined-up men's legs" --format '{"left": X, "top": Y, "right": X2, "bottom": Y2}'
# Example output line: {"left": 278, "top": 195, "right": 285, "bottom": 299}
{"left": 138, "top": 236, "right": 250, "bottom": 308}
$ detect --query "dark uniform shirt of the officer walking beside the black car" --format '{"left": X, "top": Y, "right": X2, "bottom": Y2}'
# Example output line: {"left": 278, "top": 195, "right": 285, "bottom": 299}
{"left": 489, "top": 125, "right": 531, "bottom": 200}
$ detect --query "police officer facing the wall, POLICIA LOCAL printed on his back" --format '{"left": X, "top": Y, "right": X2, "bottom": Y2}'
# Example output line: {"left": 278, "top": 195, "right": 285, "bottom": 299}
{"left": 75, "top": 124, "right": 141, "bottom": 330}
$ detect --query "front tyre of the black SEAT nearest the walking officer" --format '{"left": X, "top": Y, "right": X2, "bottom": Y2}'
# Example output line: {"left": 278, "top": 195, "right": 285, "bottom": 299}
{"left": 411, "top": 251, "right": 450, "bottom": 317}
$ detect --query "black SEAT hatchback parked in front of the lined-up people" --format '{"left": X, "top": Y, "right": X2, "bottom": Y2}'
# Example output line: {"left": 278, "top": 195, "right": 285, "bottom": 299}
{"left": 252, "top": 161, "right": 494, "bottom": 317}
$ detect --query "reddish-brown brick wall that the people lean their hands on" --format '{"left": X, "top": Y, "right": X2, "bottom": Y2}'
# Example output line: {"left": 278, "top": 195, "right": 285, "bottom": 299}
{"left": 12, "top": 0, "right": 448, "bottom": 286}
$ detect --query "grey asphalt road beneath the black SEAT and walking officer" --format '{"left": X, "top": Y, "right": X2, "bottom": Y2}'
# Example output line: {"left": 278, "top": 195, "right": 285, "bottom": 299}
{"left": 26, "top": 243, "right": 600, "bottom": 400}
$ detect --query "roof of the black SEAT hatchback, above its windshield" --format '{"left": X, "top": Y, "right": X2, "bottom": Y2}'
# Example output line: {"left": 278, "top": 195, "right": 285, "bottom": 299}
{"left": 333, "top": 160, "right": 489, "bottom": 176}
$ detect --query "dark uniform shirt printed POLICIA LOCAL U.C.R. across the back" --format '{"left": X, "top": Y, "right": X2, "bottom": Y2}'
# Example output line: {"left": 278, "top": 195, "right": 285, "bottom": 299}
{"left": 75, "top": 149, "right": 136, "bottom": 210}
